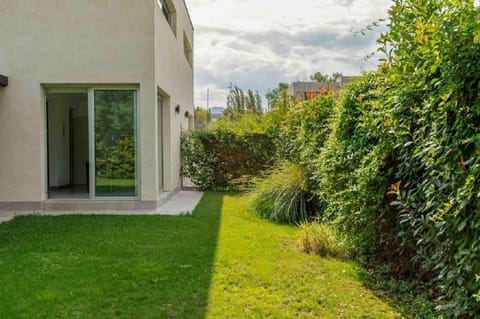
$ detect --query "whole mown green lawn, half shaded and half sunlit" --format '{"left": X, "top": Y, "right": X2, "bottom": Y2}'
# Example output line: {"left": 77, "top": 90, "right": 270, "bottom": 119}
{"left": 0, "top": 193, "right": 408, "bottom": 318}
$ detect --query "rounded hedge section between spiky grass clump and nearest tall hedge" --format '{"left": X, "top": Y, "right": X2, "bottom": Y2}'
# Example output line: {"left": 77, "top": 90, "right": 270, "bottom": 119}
{"left": 312, "top": 74, "right": 396, "bottom": 255}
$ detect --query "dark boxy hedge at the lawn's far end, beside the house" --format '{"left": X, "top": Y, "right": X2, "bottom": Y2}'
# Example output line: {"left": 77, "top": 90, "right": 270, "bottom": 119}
{"left": 181, "top": 130, "right": 275, "bottom": 190}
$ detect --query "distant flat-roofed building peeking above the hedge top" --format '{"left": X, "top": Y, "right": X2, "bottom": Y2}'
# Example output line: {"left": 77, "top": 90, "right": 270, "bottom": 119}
{"left": 287, "top": 76, "right": 359, "bottom": 102}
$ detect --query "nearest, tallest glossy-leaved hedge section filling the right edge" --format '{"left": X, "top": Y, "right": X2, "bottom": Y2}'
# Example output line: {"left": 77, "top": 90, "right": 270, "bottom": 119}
{"left": 380, "top": 0, "right": 480, "bottom": 317}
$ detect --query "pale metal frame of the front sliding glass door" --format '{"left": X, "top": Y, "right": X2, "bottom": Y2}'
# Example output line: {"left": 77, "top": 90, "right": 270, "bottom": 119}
{"left": 42, "top": 84, "right": 141, "bottom": 201}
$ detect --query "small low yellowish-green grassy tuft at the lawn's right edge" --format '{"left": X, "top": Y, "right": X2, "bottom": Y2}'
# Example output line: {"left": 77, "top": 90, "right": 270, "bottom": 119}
{"left": 297, "top": 222, "right": 353, "bottom": 258}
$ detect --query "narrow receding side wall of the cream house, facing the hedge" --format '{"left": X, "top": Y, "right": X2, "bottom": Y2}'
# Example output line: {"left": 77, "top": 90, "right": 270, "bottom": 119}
{"left": 155, "top": 0, "right": 194, "bottom": 191}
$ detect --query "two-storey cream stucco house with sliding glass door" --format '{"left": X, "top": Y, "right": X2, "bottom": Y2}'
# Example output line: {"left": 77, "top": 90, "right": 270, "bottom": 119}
{"left": 0, "top": 0, "right": 193, "bottom": 211}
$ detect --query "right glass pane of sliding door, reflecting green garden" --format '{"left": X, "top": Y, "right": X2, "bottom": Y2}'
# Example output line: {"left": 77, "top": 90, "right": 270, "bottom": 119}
{"left": 93, "top": 90, "right": 138, "bottom": 197}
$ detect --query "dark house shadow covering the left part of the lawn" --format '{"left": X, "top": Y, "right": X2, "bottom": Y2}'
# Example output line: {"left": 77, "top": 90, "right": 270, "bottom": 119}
{"left": 0, "top": 193, "right": 224, "bottom": 318}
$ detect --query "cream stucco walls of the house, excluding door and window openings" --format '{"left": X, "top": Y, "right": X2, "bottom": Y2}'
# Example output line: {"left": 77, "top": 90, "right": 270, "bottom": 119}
{"left": 0, "top": 0, "right": 193, "bottom": 209}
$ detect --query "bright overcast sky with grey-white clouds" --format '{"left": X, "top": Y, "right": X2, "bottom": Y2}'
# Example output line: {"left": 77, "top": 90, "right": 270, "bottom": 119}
{"left": 186, "top": 0, "right": 391, "bottom": 107}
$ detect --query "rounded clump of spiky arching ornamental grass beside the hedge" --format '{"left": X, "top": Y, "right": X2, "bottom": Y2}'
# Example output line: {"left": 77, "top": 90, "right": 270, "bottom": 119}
{"left": 250, "top": 161, "right": 314, "bottom": 224}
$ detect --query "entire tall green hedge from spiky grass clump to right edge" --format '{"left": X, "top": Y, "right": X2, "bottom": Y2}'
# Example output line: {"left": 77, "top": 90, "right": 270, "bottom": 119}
{"left": 314, "top": 0, "right": 480, "bottom": 318}
